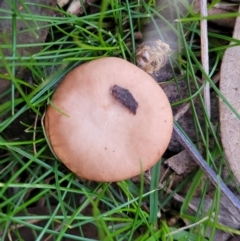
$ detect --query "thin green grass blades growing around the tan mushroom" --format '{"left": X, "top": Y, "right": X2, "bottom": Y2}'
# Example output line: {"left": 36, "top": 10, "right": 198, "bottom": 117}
{"left": 0, "top": 0, "right": 239, "bottom": 241}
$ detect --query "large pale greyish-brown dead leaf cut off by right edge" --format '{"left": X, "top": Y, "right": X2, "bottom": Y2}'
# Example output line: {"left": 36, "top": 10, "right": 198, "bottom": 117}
{"left": 219, "top": 5, "right": 240, "bottom": 181}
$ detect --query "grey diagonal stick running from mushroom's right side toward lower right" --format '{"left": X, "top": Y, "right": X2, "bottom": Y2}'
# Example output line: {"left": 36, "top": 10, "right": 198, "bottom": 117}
{"left": 173, "top": 123, "right": 240, "bottom": 211}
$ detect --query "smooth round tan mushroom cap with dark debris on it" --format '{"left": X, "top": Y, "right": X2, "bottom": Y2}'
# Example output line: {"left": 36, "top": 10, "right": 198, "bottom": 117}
{"left": 45, "top": 57, "right": 173, "bottom": 182}
